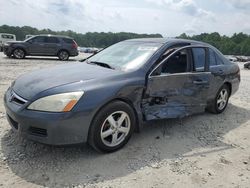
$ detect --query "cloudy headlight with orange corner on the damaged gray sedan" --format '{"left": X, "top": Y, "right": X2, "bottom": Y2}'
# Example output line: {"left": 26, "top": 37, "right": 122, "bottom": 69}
{"left": 28, "top": 91, "right": 84, "bottom": 112}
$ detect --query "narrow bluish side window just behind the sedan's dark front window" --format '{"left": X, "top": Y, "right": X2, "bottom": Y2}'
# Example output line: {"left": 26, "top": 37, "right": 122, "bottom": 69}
{"left": 192, "top": 48, "right": 206, "bottom": 72}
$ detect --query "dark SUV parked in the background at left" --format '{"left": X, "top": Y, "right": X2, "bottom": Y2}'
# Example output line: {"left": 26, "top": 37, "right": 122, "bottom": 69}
{"left": 3, "top": 35, "right": 78, "bottom": 60}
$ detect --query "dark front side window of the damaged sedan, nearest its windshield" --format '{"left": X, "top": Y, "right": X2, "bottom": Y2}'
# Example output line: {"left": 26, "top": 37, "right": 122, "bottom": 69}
{"left": 161, "top": 50, "right": 188, "bottom": 74}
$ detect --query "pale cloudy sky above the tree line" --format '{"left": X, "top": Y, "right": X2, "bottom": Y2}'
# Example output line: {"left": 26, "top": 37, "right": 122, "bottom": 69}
{"left": 0, "top": 0, "right": 250, "bottom": 37}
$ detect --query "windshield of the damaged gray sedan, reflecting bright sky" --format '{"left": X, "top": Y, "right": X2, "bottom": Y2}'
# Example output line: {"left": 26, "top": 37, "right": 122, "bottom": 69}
{"left": 87, "top": 41, "right": 162, "bottom": 71}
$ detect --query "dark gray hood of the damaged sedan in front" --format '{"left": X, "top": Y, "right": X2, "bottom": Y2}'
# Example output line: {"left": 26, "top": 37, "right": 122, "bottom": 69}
{"left": 13, "top": 63, "right": 121, "bottom": 100}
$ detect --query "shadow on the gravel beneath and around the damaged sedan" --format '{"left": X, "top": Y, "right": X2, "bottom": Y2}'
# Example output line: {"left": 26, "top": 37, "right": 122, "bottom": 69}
{"left": 1, "top": 104, "right": 250, "bottom": 187}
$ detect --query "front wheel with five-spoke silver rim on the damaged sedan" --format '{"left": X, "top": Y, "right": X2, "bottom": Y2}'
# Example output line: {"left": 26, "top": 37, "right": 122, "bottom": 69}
{"left": 88, "top": 101, "right": 136, "bottom": 153}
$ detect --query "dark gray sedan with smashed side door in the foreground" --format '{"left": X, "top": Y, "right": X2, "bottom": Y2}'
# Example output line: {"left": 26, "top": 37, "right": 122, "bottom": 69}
{"left": 4, "top": 38, "right": 240, "bottom": 152}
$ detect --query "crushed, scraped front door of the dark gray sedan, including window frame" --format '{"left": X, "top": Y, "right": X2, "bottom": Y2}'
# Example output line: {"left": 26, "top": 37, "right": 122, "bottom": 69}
{"left": 142, "top": 47, "right": 210, "bottom": 120}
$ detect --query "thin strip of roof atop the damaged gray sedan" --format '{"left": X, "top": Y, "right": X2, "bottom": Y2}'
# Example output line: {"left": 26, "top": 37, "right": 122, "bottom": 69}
{"left": 126, "top": 38, "right": 210, "bottom": 46}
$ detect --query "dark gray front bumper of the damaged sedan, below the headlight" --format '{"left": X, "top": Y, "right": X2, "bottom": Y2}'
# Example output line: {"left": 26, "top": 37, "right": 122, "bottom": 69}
{"left": 4, "top": 89, "right": 91, "bottom": 145}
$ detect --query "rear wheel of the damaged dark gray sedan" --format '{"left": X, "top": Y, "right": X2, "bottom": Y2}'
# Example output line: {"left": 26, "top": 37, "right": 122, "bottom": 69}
{"left": 208, "top": 84, "right": 230, "bottom": 114}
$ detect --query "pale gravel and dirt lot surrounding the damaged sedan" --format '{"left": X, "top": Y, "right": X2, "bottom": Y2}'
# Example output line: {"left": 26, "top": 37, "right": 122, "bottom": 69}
{"left": 0, "top": 53, "right": 250, "bottom": 188}
